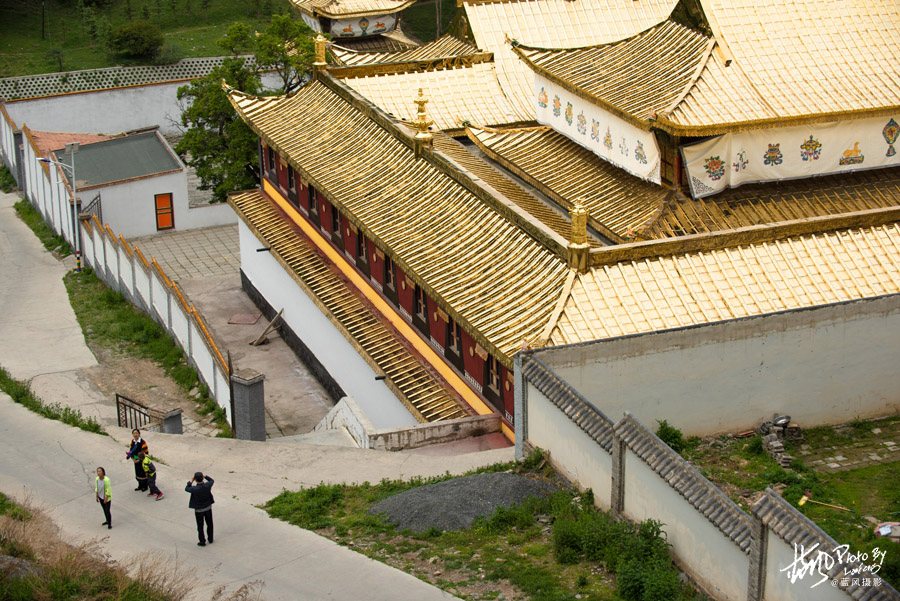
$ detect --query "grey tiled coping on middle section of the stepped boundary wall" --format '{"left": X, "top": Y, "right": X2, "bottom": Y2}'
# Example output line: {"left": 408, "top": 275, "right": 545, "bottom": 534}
{"left": 613, "top": 411, "right": 753, "bottom": 554}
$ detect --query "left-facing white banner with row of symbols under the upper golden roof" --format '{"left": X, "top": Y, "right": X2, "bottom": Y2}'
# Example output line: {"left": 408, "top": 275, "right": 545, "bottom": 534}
{"left": 534, "top": 75, "right": 660, "bottom": 184}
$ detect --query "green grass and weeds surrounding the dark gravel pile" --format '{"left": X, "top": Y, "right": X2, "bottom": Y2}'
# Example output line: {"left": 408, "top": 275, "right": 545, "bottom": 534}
{"left": 263, "top": 460, "right": 701, "bottom": 601}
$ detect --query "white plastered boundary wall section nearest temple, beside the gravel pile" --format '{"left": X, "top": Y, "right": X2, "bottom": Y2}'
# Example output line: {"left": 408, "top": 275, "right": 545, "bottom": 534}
{"left": 525, "top": 384, "right": 612, "bottom": 509}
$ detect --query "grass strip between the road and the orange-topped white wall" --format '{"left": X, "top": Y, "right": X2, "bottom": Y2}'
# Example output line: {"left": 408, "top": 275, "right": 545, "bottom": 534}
{"left": 63, "top": 267, "right": 232, "bottom": 438}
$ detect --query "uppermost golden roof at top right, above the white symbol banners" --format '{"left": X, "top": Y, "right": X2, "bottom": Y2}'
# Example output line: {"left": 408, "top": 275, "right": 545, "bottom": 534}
{"left": 506, "top": 0, "right": 900, "bottom": 136}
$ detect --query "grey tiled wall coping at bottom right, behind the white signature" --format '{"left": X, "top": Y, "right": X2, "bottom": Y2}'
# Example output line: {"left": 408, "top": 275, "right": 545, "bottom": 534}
{"left": 750, "top": 488, "right": 900, "bottom": 601}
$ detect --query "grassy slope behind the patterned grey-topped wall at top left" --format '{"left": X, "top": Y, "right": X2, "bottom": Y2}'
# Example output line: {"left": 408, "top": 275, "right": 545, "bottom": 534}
{"left": 0, "top": 0, "right": 290, "bottom": 77}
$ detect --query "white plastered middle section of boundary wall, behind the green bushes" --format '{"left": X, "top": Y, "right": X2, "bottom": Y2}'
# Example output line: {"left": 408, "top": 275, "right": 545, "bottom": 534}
{"left": 624, "top": 450, "right": 748, "bottom": 601}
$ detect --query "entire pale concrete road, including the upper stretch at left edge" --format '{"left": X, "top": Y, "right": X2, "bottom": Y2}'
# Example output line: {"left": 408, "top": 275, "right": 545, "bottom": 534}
{"left": 0, "top": 190, "right": 513, "bottom": 601}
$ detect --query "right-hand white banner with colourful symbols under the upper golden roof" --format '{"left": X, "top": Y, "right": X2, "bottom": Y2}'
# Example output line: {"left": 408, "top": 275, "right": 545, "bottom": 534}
{"left": 681, "top": 114, "right": 900, "bottom": 198}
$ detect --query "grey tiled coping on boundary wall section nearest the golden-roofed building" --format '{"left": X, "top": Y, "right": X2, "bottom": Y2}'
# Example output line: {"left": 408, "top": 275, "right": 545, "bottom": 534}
{"left": 522, "top": 353, "right": 613, "bottom": 453}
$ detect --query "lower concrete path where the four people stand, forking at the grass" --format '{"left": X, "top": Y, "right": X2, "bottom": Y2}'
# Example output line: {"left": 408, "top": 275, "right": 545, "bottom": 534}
{"left": 0, "top": 393, "right": 512, "bottom": 601}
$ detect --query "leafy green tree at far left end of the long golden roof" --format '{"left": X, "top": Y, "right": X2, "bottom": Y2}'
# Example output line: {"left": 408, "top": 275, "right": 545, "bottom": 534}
{"left": 175, "top": 57, "right": 261, "bottom": 202}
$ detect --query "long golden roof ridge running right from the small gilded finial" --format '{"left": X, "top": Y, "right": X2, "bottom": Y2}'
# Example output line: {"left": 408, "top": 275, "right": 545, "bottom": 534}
{"left": 590, "top": 206, "right": 900, "bottom": 267}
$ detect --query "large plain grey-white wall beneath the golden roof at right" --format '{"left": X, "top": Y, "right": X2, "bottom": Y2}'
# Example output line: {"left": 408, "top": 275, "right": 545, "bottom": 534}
{"left": 541, "top": 295, "right": 900, "bottom": 435}
